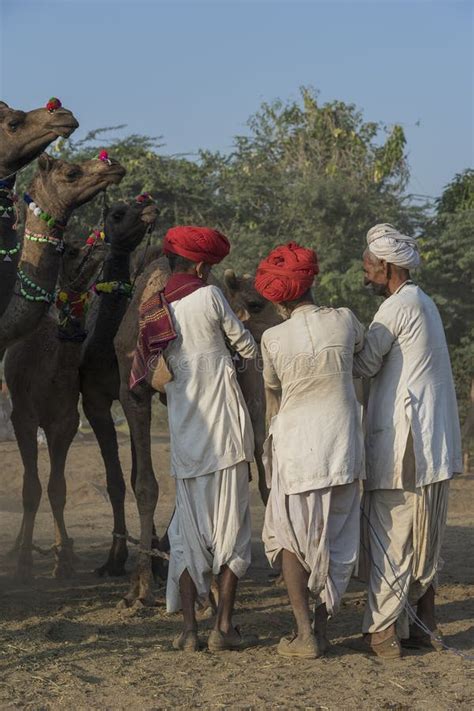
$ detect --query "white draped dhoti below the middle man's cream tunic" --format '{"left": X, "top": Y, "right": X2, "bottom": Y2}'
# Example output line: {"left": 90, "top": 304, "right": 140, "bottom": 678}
{"left": 262, "top": 469, "right": 360, "bottom": 615}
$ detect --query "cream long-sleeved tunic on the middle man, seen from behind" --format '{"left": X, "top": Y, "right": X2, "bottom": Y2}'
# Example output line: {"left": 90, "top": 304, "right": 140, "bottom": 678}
{"left": 262, "top": 305, "right": 364, "bottom": 494}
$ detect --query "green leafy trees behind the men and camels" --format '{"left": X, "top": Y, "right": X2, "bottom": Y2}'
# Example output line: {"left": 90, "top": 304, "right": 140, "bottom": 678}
{"left": 12, "top": 88, "right": 474, "bottom": 422}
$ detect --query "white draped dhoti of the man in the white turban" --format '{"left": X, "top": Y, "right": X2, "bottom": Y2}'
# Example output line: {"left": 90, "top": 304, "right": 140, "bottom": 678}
{"left": 359, "top": 480, "right": 449, "bottom": 639}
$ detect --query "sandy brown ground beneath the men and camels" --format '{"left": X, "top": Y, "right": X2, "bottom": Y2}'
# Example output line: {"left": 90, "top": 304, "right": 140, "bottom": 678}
{"left": 0, "top": 426, "right": 474, "bottom": 711}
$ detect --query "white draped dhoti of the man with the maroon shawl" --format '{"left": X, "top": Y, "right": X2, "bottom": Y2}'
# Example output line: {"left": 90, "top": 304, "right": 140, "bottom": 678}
{"left": 166, "top": 462, "right": 252, "bottom": 612}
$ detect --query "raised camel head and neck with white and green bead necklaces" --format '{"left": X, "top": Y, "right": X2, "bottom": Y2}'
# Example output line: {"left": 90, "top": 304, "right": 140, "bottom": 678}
{"left": 0, "top": 153, "right": 125, "bottom": 354}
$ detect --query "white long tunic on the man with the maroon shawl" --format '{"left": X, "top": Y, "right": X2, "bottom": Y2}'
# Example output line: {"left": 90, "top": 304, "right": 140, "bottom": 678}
{"left": 165, "top": 286, "right": 258, "bottom": 479}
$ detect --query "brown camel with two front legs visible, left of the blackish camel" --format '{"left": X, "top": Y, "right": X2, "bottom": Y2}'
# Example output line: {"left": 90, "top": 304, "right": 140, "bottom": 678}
{"left": 5, "top": 239, "right": 106, "bottom": 582}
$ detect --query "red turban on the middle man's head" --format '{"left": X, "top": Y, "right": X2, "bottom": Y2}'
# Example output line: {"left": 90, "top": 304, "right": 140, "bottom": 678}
{"left": 255, "top": 242, "right": 319, "bottom": 303}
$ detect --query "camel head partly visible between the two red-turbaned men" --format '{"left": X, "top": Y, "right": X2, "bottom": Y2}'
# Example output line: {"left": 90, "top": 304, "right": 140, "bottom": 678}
{"left": 224, "top": 269, "right": 282, "bottom": 343}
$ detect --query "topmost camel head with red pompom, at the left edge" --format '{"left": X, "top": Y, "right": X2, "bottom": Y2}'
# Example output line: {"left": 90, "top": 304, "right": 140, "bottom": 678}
{"left": 0, "top": 101, "right": 79, "bottom": 180}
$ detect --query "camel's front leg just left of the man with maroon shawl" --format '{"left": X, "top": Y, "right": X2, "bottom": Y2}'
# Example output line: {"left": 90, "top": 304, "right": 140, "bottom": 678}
{"left": 120, "top": 382, "right": 158, "bottom": 605}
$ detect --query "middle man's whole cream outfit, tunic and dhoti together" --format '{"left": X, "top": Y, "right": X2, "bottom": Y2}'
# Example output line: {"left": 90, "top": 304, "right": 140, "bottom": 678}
{"left": 262, "top": 305, "right": 363, "bottom": 615}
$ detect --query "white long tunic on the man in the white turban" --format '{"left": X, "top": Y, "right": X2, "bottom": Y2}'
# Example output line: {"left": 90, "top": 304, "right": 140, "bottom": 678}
{"left": 354, "top": 282, "right": 462, "bottom": 490}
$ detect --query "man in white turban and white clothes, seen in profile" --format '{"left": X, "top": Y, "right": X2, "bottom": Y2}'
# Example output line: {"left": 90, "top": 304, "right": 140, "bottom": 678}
{"left": 354, "top": 224, "right": 462, "bottom": 658}
